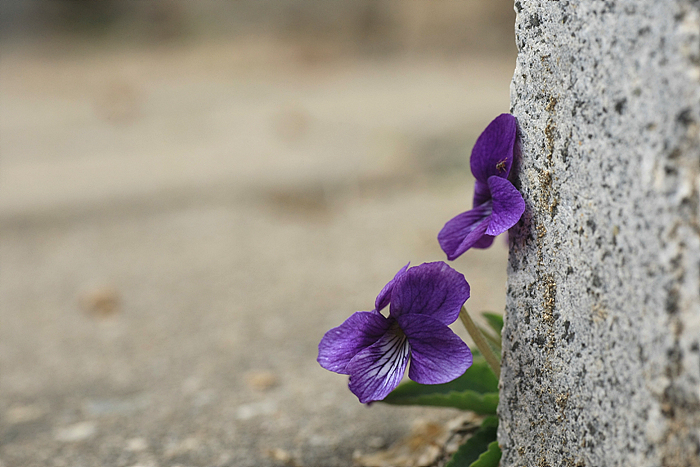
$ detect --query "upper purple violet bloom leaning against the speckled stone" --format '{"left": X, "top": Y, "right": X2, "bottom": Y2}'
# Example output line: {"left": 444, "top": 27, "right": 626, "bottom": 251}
{"left": 438, "top": 114, "right": 525, "bottom": 261}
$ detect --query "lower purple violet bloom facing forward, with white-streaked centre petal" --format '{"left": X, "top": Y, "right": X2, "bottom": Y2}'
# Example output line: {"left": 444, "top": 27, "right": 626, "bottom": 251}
{"left": 318, "top": 261, "right": 472, "bottom": 404}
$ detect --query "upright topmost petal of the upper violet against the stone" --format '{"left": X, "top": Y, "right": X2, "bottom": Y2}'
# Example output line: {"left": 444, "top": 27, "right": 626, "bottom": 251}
{"left": 469, "top": 114, "right": 517, "bottom": 182}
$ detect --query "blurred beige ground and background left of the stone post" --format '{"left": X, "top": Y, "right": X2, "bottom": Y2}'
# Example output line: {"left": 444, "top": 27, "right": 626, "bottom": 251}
{"left": 0, "top": 0, "right": 516, "bottom": 467}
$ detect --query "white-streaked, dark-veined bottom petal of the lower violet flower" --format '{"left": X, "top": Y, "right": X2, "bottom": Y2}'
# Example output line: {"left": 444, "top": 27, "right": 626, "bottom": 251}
{"left": 346, "top": 326, "right": 410, "bottom": 404}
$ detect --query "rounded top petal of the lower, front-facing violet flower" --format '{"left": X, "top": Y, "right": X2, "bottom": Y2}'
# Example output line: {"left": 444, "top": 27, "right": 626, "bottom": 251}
{"left": 389, "top": 261, "right": 469, "bottom": 324}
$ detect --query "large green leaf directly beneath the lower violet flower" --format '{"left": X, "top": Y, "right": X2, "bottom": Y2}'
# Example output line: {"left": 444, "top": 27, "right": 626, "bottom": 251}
{"left": 382, "top": 356, "right": 498, "bottom": 415}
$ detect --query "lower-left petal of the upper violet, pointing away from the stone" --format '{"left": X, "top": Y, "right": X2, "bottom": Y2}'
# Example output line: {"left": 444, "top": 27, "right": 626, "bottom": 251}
{"left": 438, "top": 202, "right": 492, "bottom": 261}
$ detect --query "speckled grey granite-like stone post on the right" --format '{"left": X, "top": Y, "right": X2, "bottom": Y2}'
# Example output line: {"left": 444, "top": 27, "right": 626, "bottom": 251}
{"left": 499, "top": 0, "right": 700, "bottom": 467}
